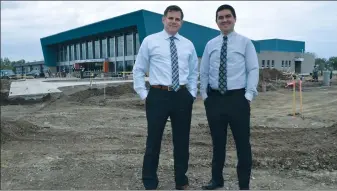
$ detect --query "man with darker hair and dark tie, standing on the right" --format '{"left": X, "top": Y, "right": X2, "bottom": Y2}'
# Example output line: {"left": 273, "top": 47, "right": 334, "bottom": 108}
{"left": 200, "top": 5, "right": 259, "bottom": 190}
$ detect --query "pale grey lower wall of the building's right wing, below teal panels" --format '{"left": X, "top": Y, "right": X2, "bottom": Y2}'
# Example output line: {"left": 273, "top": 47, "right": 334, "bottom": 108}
{"left": 258, "top": 51, "right": 315, "bottom": 74}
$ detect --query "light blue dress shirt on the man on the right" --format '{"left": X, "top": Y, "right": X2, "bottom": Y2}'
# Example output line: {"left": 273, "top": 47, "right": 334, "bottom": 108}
{"left": 200, "top": 32, "right": 259, "bottom": 101}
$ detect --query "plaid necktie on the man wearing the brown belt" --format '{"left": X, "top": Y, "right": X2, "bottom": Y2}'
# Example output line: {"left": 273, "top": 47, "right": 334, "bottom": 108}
{"left": 170, "top": 36, "right": 179, "bottom": 91}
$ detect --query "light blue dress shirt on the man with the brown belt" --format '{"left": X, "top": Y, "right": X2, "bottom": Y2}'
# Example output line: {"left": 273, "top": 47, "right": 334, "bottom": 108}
{"left": 133, "top": 30, "right": 198, "bottom": 100}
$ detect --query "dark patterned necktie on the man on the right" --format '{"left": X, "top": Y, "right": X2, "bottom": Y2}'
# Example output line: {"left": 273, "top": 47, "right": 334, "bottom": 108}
{"left": 219, "top": 36, "right": 227, "bottom": 94}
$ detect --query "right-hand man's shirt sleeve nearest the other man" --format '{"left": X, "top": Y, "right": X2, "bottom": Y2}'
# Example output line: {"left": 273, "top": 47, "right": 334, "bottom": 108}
{"left": 200, "top": 43, "right": 209, "bottom": 100}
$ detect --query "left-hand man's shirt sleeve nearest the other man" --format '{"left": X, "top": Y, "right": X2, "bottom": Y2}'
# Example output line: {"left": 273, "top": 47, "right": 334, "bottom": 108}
{"left": 187, "top": 44, "right": 199, "bottom": 97}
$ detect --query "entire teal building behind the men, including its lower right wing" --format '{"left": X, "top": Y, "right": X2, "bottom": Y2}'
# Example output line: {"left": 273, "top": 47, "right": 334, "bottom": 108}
{"left": 40, "top": 10, "right": 314, "bottom": 73}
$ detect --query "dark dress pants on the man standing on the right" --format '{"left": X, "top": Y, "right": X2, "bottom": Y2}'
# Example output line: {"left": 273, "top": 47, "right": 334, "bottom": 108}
{"left": 204, "top": 89, "right": 252, "bottom": 189}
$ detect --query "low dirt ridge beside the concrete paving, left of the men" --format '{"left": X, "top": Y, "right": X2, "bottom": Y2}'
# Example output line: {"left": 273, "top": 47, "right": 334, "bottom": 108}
{"left": 69, "top": 83, "right": 136, "bottom": 102}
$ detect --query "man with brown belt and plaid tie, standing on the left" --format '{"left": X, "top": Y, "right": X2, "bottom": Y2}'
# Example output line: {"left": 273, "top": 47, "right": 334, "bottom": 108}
{"left": 133, "top": 6, "right": 198, "bottom": 190}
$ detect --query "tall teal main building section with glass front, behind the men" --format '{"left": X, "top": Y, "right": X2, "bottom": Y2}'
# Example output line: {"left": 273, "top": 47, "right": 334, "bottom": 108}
{"left": 41, "top": 10, "right": 219, "bottom": 73}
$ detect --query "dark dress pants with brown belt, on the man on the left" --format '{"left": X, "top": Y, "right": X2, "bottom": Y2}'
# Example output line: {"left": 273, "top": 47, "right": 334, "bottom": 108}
{"left": 142, "top": 87, "right": 194, "bottom": 189}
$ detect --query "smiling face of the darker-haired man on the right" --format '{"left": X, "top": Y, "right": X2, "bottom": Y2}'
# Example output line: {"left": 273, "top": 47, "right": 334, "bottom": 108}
{"left": 216, "top": 9, "right": 236, "bottom": 33}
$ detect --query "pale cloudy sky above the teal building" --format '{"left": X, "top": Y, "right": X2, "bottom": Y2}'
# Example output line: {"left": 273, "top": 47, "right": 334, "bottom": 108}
{"left": 1, "top": 1, "right": 337, "bottom": 61}
